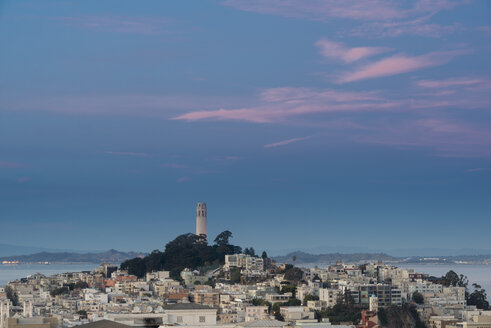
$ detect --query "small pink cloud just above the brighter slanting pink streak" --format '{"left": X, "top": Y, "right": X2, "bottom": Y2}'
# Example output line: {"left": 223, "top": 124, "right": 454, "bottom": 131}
{"left": 315, "top": 39, "right": 392, "bottom": 63}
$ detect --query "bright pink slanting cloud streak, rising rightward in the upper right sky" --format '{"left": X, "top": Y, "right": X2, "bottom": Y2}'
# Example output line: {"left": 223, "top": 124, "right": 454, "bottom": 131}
{"left": 338, "top": 50, "right": 468, "bottom": 83}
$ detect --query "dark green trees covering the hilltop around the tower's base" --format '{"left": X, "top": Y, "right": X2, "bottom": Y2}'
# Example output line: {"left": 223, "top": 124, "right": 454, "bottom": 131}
{"left": 121, "top": 230, "right": 242, "bottom": 279}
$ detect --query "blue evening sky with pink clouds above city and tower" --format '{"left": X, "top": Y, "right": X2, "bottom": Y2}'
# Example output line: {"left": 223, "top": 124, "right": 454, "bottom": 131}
{"left": 0, "top": 0, "right": 491, "bottom": 252}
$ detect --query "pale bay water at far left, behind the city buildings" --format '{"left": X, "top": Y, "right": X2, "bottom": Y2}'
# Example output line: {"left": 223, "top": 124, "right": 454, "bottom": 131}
{"left": 0, "top": 264, "right": 98, "bottom": 286}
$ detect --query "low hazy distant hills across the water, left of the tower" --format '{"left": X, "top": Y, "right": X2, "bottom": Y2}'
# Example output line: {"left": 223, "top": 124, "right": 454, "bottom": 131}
{"left": 0, "top": 249, "right": 146, "bottom": 264}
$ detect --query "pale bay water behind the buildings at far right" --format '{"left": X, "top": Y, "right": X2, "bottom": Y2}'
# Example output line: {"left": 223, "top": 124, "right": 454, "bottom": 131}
{"left": 396, "top": 264, "right": 491, "bottom": 299}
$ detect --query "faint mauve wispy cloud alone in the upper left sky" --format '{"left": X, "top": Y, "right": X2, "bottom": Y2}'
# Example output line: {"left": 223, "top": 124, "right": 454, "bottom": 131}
{"left": 53, "top": 15, "right": 171, "bottom": 35}
